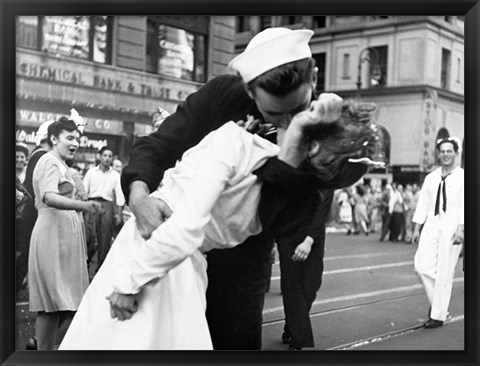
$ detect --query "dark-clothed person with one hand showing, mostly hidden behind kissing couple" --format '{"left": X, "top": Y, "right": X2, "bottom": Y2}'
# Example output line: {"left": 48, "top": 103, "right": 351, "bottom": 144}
{"left": 277, "top": 190, "right": 333, "bottom": 350}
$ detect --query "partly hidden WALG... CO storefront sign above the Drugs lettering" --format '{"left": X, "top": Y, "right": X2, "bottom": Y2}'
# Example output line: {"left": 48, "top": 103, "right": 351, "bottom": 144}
{"left": 17, "top": 109, "right": 125, "bottom": 135}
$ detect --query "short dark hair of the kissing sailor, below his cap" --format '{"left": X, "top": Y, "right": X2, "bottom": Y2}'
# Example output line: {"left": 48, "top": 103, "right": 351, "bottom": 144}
{"left": 248, "top": 57, "right": 315, "bottom": 97}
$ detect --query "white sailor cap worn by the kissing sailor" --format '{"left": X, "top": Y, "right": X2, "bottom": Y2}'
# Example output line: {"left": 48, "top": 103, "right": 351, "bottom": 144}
{"left": 228, "top": 27, "right": 313, "bottom": 83}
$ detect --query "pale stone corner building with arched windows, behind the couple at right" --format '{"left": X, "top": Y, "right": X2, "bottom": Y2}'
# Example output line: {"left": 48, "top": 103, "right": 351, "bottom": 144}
{"left": 235, "top": 16, "right": 465, "bottom": 185}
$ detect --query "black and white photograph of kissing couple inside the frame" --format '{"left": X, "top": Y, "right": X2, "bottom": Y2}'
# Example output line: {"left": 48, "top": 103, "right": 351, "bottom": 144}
{"left": 2, "top": 4, "right": 478, "bottom": 364}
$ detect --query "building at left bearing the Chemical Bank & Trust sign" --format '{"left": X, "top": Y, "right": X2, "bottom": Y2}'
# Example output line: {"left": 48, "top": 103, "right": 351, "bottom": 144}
{"left": 15, "top": 16, "right": 235, "bottom": 170}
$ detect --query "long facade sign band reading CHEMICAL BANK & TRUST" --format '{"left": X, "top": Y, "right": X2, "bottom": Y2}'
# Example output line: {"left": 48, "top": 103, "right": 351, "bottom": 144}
{"left": 16, "top": 53, "right": 199, "bottom": 102}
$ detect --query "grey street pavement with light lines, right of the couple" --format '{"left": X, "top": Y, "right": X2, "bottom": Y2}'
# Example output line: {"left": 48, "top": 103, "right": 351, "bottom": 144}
{"left": 263, "top": 229, "right": 464, "bottom": 350}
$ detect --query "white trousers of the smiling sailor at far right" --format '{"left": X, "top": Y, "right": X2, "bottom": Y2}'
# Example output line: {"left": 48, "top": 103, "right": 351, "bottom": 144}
{"left": 415, "top": 212, "right": 462, "bottom": 321}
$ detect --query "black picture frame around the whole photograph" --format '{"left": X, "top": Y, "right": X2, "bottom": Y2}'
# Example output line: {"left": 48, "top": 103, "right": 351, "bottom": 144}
{"left": 0, "top": 0, "right": 480, "bottom": 366}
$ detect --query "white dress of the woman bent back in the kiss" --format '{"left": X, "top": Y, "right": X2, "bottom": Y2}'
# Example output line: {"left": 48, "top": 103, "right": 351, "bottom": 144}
{"left": 59, "top": 122, "right": 279, "bottom": 350}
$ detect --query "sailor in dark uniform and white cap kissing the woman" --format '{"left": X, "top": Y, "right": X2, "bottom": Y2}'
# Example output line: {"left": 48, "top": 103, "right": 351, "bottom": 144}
{"left": 122, "top": 28, "right": 372, "bottom": 350}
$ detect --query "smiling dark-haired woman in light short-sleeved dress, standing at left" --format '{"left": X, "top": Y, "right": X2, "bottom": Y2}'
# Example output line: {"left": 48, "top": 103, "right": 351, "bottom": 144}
{"left": 28, "top": 117, "right": 101, "bottom": 350}
